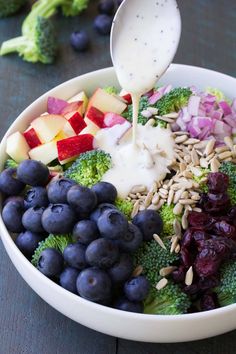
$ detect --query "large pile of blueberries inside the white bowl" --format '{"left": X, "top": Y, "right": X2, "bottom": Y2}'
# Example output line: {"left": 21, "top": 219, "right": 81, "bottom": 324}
{"left": 0, "top": 160, "right": 162, "bottom": 312}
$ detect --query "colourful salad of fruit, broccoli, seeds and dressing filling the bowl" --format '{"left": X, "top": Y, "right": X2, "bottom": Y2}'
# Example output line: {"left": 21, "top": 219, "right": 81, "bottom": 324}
{"left": 0, "top": 66, "right": 236, "bottom": 338}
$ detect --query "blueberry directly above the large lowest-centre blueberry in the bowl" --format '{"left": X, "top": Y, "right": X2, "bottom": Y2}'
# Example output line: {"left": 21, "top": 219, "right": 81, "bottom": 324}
{"left": 85, "top": 238, "right": 119, "bottom": 269}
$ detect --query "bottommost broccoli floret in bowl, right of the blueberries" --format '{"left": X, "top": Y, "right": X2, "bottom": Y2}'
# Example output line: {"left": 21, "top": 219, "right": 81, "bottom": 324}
{"left": 144, "top": 282, "right": 190, "bottom": 315}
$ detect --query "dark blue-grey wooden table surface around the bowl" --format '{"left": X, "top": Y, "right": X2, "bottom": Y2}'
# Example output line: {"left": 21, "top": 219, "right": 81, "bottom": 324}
{"left": 0, "top": 0, "right": 236, "bottom": 354}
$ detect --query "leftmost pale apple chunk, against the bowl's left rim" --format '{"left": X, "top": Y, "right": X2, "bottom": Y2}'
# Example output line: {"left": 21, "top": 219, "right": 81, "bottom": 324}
{"left": 6, "top": 132, "right": 30, "bottom": 162}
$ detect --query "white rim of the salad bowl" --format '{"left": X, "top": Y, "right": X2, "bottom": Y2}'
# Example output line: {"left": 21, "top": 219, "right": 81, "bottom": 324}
{"left": 0, "top": 64, "right": 236, "bottom": 323}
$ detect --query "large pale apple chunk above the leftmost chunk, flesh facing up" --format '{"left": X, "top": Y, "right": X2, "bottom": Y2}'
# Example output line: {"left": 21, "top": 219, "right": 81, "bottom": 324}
{"left": 31, "top": 114, "right": 67, "bottom": 143}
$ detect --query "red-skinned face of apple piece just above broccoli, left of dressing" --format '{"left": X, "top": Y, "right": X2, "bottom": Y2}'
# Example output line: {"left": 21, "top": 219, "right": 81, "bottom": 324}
{"left": 57, "top": 134, "right": 94, "bottom": 161}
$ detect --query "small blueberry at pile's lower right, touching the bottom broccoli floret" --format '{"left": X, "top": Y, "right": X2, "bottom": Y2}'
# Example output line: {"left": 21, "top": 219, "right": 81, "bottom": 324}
{"left": 124, "top": 275, "right": 150, "bottom": 301}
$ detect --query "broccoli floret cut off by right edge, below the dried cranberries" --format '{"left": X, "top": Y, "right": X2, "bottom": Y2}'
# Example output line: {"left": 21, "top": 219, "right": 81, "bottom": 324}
{"left": 215, "top": 261, "right": 236, "bottom": 306}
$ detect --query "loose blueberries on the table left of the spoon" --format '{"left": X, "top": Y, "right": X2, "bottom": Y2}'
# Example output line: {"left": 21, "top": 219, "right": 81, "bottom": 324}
{"left": 70, "top": 0, "right": 122, "bottom": 52}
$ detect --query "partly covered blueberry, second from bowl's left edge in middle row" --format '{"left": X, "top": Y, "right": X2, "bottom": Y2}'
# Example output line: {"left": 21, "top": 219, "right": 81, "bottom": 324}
{"left": 22, "top": 207, "right": 45, "bottom": 232}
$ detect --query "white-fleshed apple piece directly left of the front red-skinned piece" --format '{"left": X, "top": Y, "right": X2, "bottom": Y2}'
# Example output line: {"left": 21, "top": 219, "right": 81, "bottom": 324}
{"left": 29, "top": 140, "right": 57, "bottom": 165}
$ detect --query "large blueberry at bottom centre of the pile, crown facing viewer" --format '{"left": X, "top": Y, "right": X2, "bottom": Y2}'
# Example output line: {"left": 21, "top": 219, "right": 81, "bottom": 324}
{"left": 76, "top": 268, "right": 111, "bottom": 303}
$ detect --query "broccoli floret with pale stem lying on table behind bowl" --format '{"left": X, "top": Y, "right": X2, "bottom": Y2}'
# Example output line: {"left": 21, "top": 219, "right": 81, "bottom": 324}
{"left": 0, "top": 16, "right": 56, "bottom": 64}
